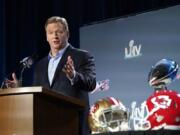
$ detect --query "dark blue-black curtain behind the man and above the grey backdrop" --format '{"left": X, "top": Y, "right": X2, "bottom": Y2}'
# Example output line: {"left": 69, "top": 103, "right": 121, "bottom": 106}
{"left": 0, "top": 0, "right": 180, "bottom": 85}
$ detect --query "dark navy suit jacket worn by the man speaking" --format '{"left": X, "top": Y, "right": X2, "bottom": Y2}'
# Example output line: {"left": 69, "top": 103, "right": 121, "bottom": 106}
{"left": 34, "top": 45, "right": 96, "bottom": 135}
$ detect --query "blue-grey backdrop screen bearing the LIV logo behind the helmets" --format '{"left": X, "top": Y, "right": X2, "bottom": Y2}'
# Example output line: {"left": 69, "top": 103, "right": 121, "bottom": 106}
{"left": 80, "top": 6, "right": 180, "bottom": 107}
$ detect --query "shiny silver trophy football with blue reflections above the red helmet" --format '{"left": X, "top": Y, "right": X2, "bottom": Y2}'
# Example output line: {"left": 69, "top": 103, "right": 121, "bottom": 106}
{"left": 148, "top": 59, "right": 178, "bottom": 89}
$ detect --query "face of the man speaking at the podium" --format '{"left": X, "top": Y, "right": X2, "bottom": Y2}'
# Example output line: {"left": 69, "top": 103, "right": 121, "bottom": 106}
{"left": 46, "top": 23, "right": 69, "bottom": 50}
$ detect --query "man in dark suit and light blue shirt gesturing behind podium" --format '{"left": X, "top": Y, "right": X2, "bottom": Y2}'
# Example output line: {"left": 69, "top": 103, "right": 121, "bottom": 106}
{"left": 7, "top": 16, "right": 96, "bottom": 135}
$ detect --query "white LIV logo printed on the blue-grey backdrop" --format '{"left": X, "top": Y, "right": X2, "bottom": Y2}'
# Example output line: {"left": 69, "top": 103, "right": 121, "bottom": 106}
{"left": 124, "top": 40, "right": 142, "bottom": 59}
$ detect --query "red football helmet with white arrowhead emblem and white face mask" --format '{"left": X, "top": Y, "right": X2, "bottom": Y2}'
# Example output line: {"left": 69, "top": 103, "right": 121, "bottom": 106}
{"left": 134, "top": 90, "right": 180, "bottom": 130}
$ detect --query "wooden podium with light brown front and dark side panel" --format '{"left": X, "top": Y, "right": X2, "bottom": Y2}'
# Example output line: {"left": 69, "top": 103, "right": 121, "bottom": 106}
{"left": 0, "top": 87, "right": 85, "bottom": 135}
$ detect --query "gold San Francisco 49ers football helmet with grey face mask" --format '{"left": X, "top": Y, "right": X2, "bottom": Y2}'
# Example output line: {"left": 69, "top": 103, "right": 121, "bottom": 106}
{"left": 88, "top": 97, "right": 129, "bottom": 134}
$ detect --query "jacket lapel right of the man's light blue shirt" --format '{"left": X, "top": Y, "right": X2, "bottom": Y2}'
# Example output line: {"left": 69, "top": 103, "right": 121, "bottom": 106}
{"left": 51, "top": 45, "right": 72, "bottom": 87}
